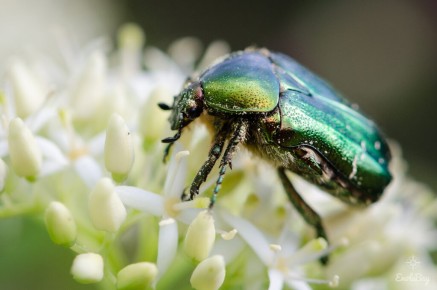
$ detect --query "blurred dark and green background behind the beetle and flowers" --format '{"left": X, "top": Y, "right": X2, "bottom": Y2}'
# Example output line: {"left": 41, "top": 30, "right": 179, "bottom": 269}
{"left": 0, "top": 0, "right": 437, "bottom": 289}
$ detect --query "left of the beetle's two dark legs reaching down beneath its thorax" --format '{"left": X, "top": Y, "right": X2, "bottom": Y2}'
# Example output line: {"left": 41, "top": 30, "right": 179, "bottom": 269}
{"left": 181, "top": 124, "right": 229, "bottom": 200}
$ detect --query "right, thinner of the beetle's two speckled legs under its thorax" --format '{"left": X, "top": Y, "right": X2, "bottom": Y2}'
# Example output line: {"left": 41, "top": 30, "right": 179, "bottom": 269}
{"left": 209, "top": 122, "right": 247, "bottom": 208}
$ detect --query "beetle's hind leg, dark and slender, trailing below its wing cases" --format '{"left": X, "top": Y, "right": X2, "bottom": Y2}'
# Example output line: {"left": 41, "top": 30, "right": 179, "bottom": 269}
{"left": 278, "top": 167, "right": 328, "bottom": 264}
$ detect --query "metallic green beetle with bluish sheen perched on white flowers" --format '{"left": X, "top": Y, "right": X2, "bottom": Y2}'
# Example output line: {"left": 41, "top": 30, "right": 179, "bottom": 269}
{"left": 159, "top": 49, "right": 391, "bottom": 251}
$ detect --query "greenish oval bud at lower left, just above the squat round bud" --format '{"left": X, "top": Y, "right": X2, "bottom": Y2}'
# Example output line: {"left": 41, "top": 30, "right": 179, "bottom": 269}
{"left": 45, "top": 201, "right": 77, "bottom": 247}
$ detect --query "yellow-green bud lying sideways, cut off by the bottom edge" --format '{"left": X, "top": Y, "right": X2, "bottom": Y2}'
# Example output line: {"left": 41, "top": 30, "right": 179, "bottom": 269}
{"left": 117, "top": 262, "right": 158, "bottom": 290}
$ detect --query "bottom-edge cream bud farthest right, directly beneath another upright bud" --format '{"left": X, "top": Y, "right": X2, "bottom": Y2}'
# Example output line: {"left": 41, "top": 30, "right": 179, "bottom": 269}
{"left": 190, "top": 255, "right": 226, "bottom": 290}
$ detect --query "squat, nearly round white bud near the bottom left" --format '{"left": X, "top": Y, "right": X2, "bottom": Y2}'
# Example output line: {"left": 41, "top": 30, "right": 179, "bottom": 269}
{"left": 71, "top": 253, "right": 103, "bottom": 284}
